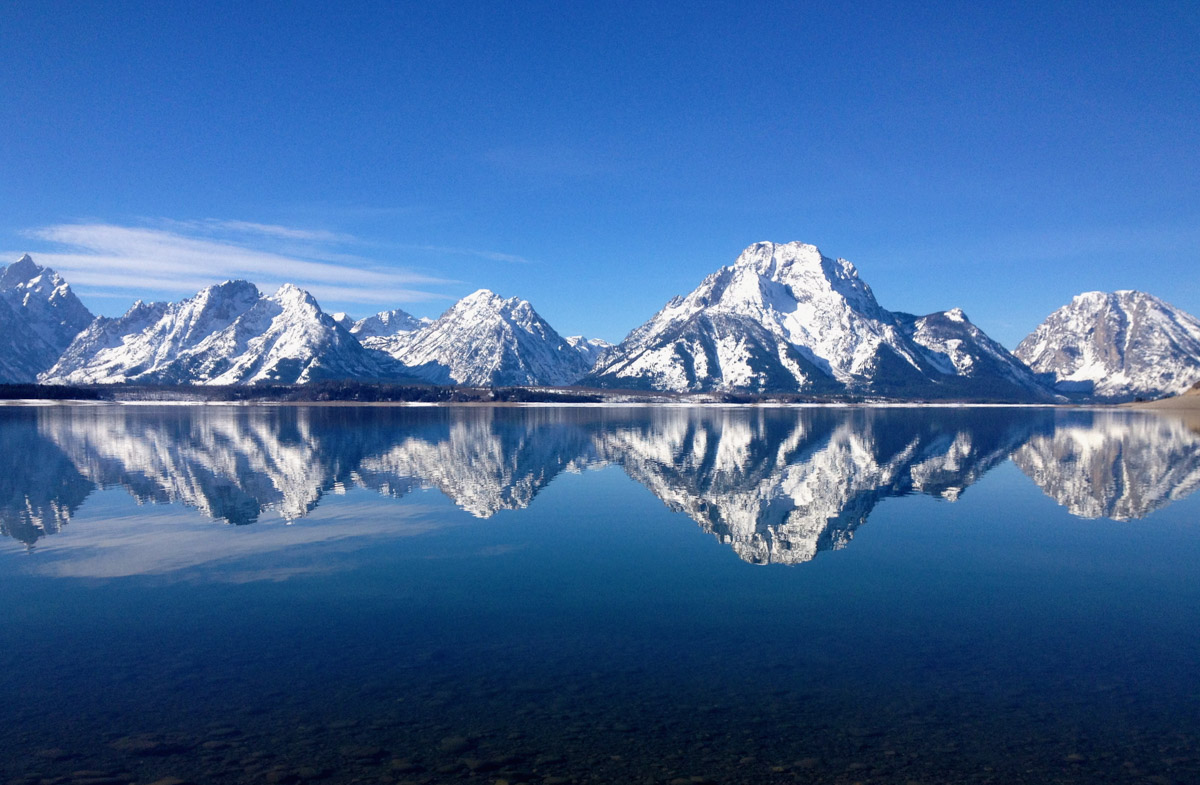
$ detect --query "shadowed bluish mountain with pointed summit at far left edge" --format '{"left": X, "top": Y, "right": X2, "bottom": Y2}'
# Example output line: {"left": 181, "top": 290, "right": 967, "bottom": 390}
{"left": 0, "top": 253, "right": 92, "bottom": 383}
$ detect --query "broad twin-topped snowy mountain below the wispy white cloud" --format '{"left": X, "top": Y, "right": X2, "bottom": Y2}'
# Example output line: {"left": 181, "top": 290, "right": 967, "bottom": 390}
{"left": 40, "top": 281, "right": 395, "bottom": 384}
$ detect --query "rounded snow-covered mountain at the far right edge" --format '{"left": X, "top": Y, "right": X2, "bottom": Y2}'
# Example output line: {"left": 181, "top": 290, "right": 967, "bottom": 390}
{"left": 1016, "top": 290, "right": 1200, "bottom": 401}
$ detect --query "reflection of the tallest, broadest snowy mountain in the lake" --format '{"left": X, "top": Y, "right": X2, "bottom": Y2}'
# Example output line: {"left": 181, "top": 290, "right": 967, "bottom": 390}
{"left": 605, "top": 409, "right": 1045, "bottom": 564}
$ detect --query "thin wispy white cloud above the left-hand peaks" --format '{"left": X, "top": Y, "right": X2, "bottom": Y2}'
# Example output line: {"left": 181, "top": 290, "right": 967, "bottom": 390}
{"left": 26, "top": 220, "right": 463, "bottom": 304}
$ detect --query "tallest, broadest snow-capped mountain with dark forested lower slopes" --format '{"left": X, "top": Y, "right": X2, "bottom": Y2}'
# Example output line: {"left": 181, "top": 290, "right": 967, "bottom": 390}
{"left": 586, "top": 242, "right": 1045, "bottom": 397}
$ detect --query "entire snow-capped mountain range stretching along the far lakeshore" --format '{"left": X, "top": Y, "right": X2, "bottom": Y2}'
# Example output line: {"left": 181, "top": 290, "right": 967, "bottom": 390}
{"left": 7, "top": 242, "right": 1200, "bottom": 402}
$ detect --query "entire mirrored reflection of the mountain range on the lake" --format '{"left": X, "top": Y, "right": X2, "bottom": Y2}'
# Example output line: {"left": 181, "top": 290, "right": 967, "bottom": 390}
{"left": 0, "top": 406, "right": 1200, "bottom": 563}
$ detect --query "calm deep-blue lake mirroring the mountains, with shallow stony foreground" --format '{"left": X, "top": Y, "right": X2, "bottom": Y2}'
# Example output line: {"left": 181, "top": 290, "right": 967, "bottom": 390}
{"left": 0, "top": 406, "right": 1200, "bottom": 785}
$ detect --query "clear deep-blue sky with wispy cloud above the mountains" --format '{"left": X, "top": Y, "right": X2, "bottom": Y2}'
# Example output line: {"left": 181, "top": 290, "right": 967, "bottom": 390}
{"left": 0, "top": 1, "right": 1200, "bottom": 348}
